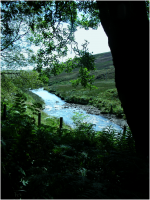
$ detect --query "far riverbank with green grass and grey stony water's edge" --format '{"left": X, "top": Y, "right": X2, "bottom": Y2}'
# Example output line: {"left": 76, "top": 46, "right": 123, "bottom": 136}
{"left": 44, "top": 86, "right": 128, "bottom": 128}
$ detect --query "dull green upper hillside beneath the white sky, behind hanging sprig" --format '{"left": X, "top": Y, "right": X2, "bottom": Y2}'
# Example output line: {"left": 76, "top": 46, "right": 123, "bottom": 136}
{"left": 49, "top": 52, "right": 115, "bottom": 85}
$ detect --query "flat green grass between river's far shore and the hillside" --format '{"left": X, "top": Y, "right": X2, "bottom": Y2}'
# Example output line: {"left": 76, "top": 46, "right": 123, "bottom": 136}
{"left": 44, "top": 79, "right": 126, "bottom": 119}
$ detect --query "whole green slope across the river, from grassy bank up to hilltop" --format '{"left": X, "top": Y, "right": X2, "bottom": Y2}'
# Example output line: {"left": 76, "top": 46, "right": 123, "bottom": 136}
{"left": 44, "top": 52, "right": 126, "bottom": 119}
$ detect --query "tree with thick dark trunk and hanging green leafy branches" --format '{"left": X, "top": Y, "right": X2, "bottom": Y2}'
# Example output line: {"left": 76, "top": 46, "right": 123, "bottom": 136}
{"left": 1, "top": 1, "right": 149, "bottom": 155}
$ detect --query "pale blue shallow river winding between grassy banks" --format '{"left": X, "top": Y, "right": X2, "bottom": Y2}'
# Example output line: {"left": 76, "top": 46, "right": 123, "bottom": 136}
{"left": 31, "top": 88, "right": 123, "bottom": 132}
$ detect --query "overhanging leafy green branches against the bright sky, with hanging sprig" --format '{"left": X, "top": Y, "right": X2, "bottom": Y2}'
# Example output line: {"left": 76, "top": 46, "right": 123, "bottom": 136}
{"left": 2, "top": 1, "right": 100, "bottom": 88}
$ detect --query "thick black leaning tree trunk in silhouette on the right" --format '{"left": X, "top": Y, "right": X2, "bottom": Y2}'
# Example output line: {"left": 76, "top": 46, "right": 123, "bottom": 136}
{"left": 97, "top": 1, "right": 149, "bottom": 156}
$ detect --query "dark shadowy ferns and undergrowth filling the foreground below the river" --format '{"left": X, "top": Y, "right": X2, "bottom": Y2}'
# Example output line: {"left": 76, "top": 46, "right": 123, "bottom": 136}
{"left": 1, "top": 94, "right": 149, "bottom": 199}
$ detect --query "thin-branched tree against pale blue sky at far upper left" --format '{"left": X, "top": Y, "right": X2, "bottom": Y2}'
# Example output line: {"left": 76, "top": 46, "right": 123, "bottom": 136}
{"left": 1, "top": 2, "right": 37, "bottom": 69}
